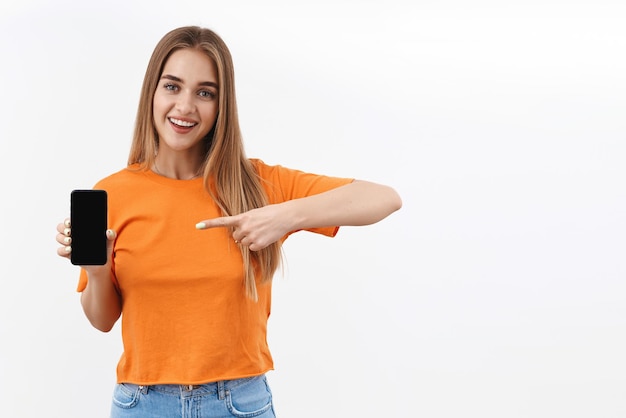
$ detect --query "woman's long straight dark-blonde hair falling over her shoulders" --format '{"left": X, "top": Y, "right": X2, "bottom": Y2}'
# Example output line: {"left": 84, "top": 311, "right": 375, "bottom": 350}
{"left": 128, "top": 26, "right": 281, "bottom": 300}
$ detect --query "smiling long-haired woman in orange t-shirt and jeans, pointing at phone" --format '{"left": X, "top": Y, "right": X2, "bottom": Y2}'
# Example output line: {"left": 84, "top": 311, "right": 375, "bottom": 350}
{"left": 57, "top": 27, "right": 402, "bottom": 417}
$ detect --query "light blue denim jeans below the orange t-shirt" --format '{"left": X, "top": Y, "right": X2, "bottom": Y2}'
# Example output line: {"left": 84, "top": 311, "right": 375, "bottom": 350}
{"left": 111, "top": 375, "right": 276, "bottom": 418}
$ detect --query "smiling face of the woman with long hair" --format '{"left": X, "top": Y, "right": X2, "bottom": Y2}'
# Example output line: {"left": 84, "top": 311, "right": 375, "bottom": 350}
{"left": 153, "top": 48, "right": 219, "bottom": 156}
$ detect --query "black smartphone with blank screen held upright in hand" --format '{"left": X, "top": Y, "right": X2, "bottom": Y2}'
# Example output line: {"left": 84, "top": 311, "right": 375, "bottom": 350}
{"left": 70, "top": 189, "right": 107, "bottom": 266}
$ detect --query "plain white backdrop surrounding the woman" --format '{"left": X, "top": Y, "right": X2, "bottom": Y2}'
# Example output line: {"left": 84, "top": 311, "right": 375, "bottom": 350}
{"left": 0, "top": 0, "right": 626, "bottom": 418}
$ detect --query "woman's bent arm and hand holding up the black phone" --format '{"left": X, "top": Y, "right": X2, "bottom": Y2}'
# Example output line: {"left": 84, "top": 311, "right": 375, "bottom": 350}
{"left": 57, "top": 219, "right": 122, "bottom": 332}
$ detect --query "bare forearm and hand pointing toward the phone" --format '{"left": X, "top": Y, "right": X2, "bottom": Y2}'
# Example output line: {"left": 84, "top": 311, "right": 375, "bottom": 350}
{"left": 196, "top": 180, "right": 402, "bottom": 251}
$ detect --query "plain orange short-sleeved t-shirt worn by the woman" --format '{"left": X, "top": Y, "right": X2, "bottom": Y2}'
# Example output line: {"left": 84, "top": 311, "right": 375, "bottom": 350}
{"left": 77, "top": 160, "right": 352, "bottom": 385}
